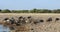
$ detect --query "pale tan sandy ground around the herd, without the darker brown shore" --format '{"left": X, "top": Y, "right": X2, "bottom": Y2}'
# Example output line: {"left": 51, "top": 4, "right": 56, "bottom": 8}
{"left": 0, "top": 13, "right": 60, "bottom": 32}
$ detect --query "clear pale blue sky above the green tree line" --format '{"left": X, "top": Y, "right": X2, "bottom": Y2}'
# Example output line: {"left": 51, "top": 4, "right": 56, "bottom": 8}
{"left": 0, "top": 0, "right": 60, "bottom": 10}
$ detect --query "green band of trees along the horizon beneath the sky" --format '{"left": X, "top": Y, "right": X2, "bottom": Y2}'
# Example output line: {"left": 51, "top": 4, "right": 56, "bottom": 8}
{"left": 0, "top": 9, "right": 60, "bottom": 13}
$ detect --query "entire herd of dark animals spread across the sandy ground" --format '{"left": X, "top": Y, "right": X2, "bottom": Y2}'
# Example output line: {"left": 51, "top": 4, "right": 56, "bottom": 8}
{"left": 3, "top": 16, "right": 60, "bottom": 31}
